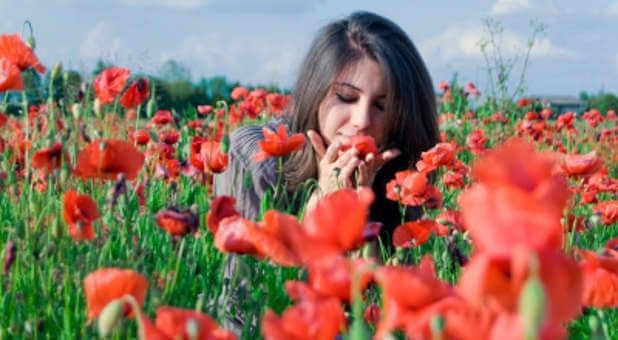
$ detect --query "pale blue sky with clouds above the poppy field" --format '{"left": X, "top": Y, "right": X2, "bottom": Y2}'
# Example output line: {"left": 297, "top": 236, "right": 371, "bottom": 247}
{"left": 0, "top": 0, "right": 618, "bottom": 95}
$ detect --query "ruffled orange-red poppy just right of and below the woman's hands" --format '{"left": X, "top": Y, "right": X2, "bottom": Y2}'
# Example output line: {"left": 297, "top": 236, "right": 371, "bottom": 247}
{"left": 386, "top": 170, "right": 428, "bottom": 206}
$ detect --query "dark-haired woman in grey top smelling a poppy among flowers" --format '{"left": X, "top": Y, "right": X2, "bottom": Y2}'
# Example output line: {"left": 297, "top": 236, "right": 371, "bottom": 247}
{"left": 215, "top": 12, "right": 438, "bottom": 334}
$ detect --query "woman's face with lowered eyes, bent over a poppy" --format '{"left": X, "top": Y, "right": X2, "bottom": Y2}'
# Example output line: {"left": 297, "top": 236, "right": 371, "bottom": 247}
{"left": 318, "top": 57, "right": 387, "bottom": 148}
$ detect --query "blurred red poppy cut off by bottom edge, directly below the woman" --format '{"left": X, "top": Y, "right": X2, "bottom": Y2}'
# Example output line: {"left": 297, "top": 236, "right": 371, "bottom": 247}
{"left": 262, "top": 281, "right": 346, "bottom": 340}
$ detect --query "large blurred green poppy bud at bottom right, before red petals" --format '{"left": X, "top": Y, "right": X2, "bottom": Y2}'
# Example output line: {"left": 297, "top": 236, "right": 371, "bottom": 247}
{"left": 519, "top": 268, "right": 546, "bottom": 340}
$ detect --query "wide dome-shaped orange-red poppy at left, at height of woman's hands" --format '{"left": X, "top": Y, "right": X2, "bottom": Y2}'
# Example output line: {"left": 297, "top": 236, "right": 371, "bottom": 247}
{"left": 74, "top": 139, "right": 144, "bottom": 180}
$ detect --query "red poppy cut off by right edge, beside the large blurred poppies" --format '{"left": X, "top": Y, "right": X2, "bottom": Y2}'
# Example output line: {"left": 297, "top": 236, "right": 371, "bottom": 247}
{"left": 579, "top": 250, "right": 618, "bottom": 308}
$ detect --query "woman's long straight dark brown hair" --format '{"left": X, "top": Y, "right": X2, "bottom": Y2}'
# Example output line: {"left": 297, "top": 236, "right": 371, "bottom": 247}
{"left": 284, "top": 12, "right": 438, "bottom": 234}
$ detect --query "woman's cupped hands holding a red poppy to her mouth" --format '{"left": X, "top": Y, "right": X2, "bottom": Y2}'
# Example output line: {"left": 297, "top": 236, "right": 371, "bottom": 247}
{"left": 307, "top": 130, "right": 401, "bottom": 194}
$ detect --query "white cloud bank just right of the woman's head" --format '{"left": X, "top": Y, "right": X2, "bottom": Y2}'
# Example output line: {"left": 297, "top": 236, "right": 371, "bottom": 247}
{"left": 419, "top": 25, "right": 575, "bottom": 62}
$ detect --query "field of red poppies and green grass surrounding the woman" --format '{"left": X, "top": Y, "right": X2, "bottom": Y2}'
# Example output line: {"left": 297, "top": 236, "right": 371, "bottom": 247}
{"left": 0, "top": 34, "right": 618, "bottom": 340}
